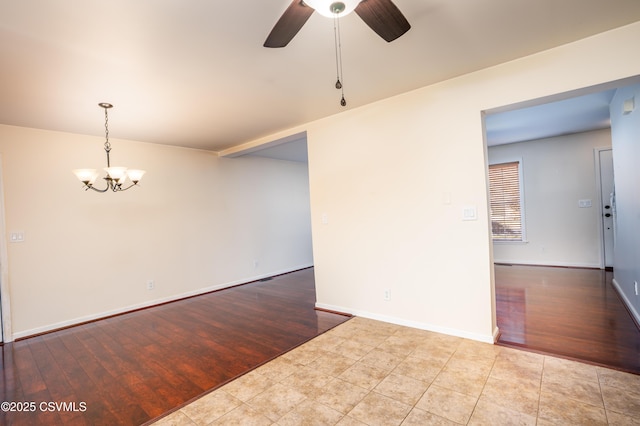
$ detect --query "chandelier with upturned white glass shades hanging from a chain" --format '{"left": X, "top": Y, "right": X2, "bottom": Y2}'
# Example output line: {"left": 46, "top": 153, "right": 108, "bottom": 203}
{"left": 73, "top": 102, "right": 145, "bottom": 192}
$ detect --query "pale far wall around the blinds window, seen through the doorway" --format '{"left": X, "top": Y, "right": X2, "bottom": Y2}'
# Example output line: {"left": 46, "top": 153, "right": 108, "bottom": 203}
{"left": 488, "top": 129, "right": 611, "bottom": 268}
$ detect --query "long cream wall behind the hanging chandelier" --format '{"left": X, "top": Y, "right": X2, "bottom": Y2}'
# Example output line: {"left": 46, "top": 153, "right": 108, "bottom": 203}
{"left": 0, "top": 126, "right": 313, "bottom": 338}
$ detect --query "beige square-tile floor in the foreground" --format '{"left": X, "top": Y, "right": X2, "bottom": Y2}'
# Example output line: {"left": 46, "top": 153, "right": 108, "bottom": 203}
{"left": 155, "top": 317, "right": 640, "bottom": 426}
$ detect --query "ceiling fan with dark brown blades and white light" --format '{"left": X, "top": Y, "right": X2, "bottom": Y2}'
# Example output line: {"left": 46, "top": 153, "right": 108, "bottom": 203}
{"left": 264, "top": 0, "right": 411, "bottom": 47}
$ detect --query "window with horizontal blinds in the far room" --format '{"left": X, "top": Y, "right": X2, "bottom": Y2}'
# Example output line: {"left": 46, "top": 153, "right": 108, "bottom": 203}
{"left": 489, "top": 161, "right": 524, "bottom": 241}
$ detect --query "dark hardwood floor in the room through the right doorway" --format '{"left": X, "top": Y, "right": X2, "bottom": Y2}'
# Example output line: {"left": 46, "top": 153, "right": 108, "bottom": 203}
{"left": 495, "top": 265, "right": 640, "bottom": 374}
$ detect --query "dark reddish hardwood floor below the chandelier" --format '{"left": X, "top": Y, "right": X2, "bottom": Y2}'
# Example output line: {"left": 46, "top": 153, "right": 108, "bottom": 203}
{"left": 0, "top": 268, "right": 348, "bottom": 425}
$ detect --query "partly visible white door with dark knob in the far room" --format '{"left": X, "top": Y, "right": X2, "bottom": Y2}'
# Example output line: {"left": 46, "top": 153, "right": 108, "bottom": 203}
{"left": 598, "top": 149, "right": 615, "bottom": 268}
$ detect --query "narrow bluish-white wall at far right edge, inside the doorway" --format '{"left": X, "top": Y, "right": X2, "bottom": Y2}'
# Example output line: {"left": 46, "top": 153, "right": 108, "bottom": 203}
{"left": 610, "top": 85, "right": 640, "bottom": 323}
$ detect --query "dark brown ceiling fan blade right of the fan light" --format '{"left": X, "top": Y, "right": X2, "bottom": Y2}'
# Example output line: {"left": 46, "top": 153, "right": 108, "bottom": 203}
{"left": 355, "top": 0, "right": 411, "bottom": 42}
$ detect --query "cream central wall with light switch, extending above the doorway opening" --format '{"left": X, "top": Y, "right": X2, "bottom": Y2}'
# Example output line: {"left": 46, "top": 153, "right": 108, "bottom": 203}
{"left": 306, "top": 23, "right": 640, "bottom": 341}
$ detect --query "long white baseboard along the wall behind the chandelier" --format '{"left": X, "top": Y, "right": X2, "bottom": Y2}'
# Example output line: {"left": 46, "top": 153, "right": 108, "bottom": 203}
{"left": 12, "top": 264, "right": 313, "bottom": 340}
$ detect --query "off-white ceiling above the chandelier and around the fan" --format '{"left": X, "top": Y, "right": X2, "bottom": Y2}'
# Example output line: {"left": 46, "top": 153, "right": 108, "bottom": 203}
{"left": 0, "top": 0, "right": 640, "bottom": 151}
